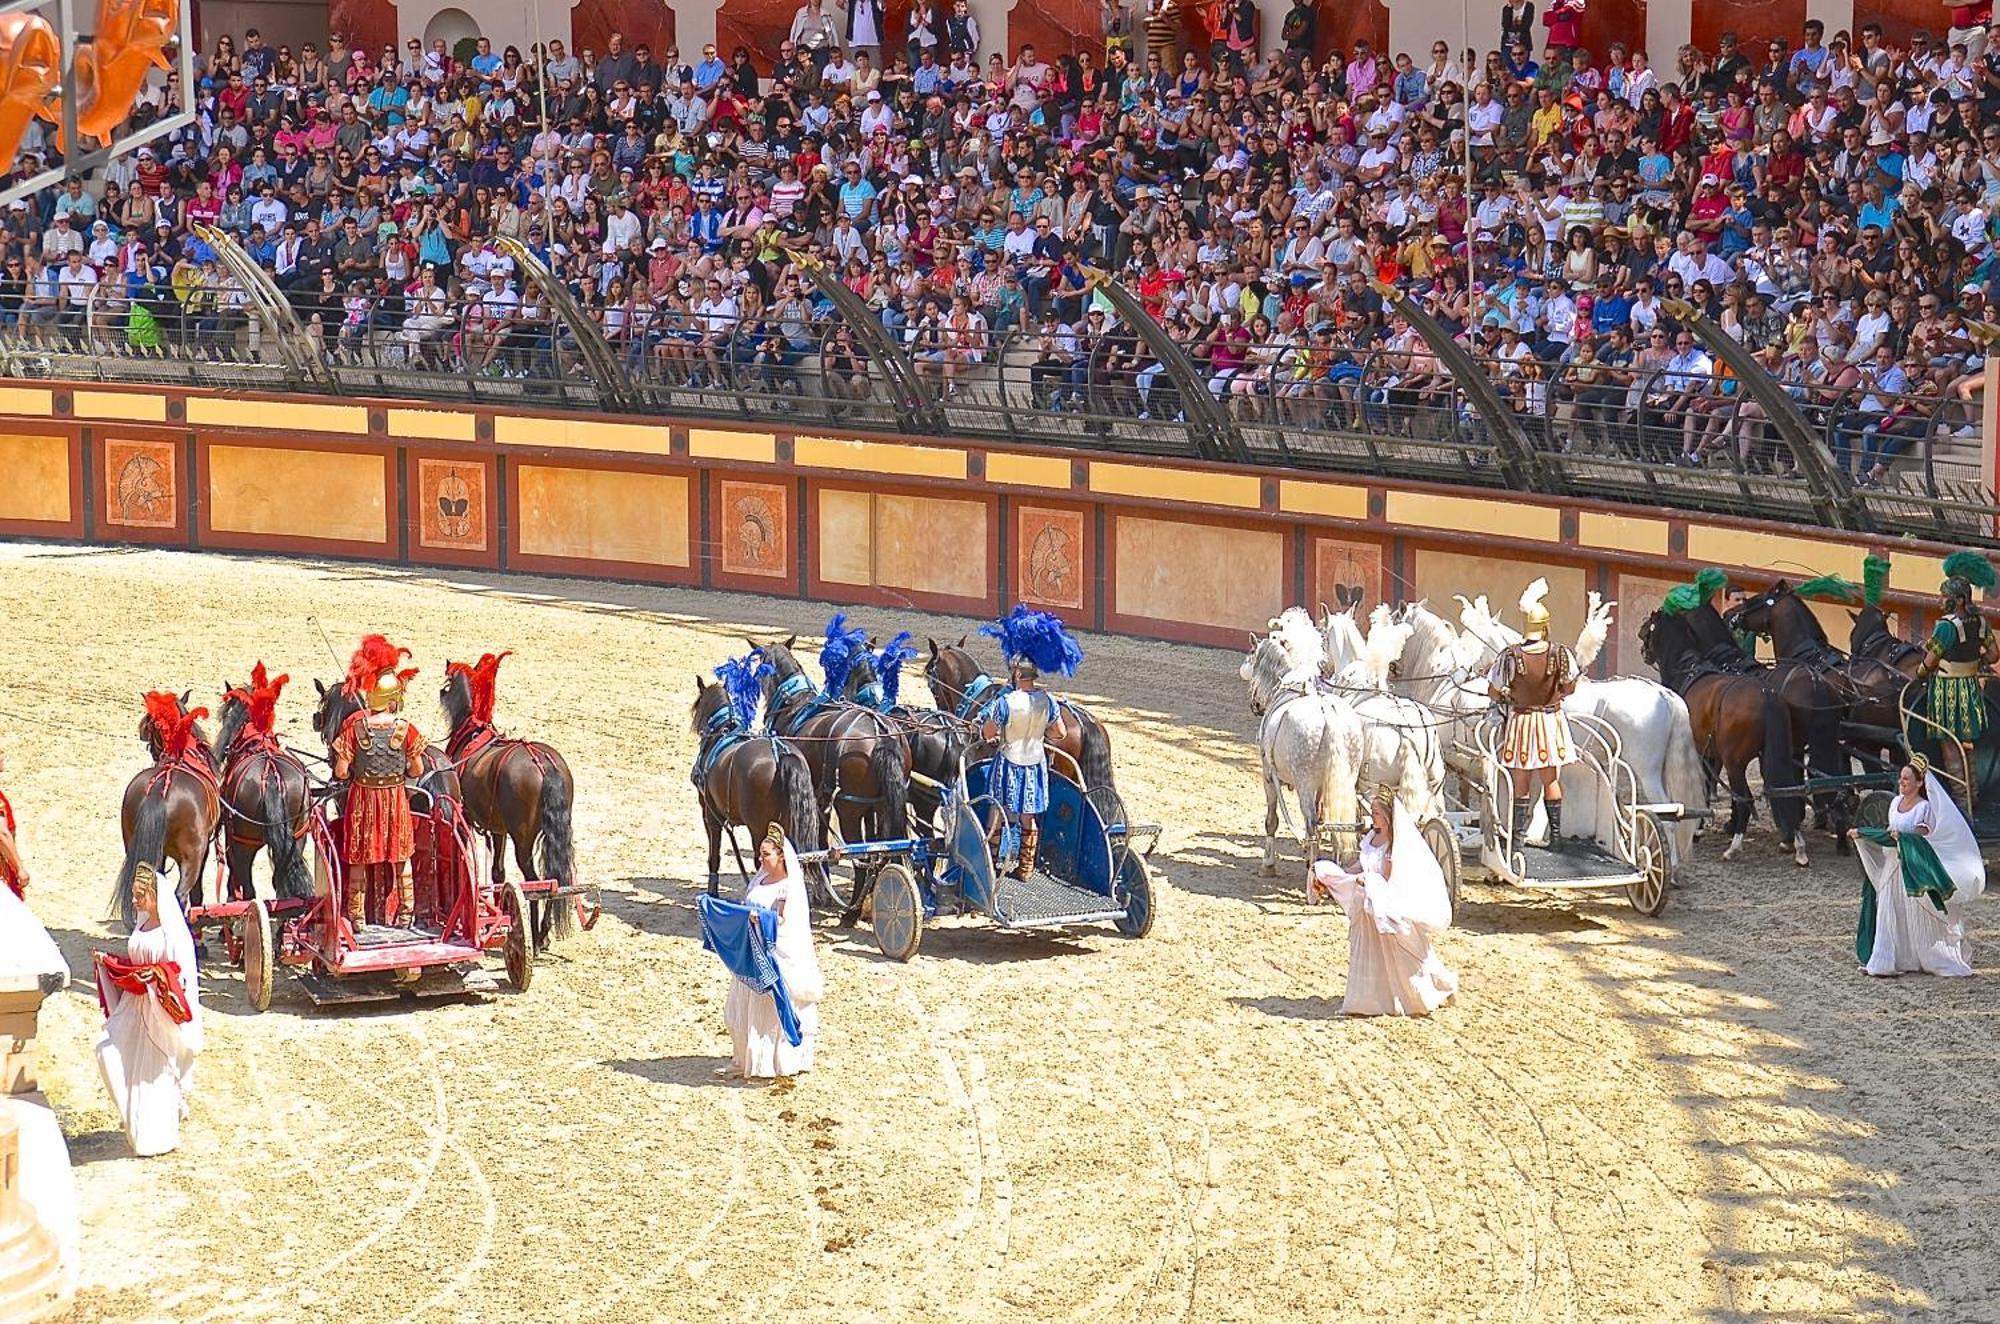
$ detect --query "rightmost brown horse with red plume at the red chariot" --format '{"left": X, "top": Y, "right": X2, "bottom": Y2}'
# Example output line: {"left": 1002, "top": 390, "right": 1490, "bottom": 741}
{"left": 438, "top": 652, "right": 578, "bottom": 946}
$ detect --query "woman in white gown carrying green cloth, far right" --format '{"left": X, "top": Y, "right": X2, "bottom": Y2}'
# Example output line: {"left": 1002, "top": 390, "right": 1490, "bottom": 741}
{"left": 1848, "top": 756, "right": 1986, "bottom": 976}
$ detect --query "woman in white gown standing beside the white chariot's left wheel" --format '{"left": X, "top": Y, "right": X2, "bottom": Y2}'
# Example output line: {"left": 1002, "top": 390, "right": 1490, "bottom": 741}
{"left": 1306, "top": 790, "right": 1458, "bottom": 1016}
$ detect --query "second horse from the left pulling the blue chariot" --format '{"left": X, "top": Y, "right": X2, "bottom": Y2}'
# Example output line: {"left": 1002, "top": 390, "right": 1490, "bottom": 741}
{"left": 750, "top": 636, "right": 910, "bottom": 922}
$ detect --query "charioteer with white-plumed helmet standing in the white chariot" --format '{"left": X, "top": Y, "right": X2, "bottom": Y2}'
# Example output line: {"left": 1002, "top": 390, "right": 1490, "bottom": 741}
{"left": 1486, "top": 580, "right": 1582, "bottom": 850}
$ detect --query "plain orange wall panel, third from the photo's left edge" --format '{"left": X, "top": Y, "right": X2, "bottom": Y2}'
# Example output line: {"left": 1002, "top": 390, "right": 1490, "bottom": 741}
{"left": 514, "top": 464, "right": 688, "bottom": 568}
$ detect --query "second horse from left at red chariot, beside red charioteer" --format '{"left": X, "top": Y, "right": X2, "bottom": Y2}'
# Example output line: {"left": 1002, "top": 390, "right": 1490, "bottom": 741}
{"left": 216, "top": 662, "right": 312, "bottom": 900}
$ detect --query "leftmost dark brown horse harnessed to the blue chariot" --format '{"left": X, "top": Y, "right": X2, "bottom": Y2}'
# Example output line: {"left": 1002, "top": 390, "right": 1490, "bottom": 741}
{"left": 690, "top": 676, "right": 824, "bottom": 896}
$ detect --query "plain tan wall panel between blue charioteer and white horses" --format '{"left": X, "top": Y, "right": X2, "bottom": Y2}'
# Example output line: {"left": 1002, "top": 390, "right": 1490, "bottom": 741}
{"left": 1112, "top": 514, "right": 1286, "bottom": 630}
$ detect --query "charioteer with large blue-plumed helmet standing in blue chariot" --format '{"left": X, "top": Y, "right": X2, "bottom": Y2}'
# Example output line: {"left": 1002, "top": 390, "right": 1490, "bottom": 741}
{"left": 978, "top": 602, "right": 1084, "bottom": 878}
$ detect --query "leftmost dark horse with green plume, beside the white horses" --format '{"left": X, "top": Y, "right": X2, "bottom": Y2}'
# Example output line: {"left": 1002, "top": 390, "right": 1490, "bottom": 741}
{"left": 1638, "top": 606, "right": 1806, "bottom": 866}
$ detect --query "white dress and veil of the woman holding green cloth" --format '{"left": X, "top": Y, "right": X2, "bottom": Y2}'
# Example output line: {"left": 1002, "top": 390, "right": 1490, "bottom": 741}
{"left": 1854, "top": 774, "right": 1986, "bottom": 976}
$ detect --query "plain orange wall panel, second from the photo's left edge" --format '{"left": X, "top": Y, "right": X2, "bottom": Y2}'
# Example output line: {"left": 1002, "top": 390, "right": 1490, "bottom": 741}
{"left": 208, "top": 446, "right": 388, "bottom": 544}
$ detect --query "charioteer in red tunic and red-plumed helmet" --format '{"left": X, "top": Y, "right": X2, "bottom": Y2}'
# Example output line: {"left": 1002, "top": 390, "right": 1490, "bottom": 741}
{"left": 334, "top": 634, "right": 426, "bottom": 924}
